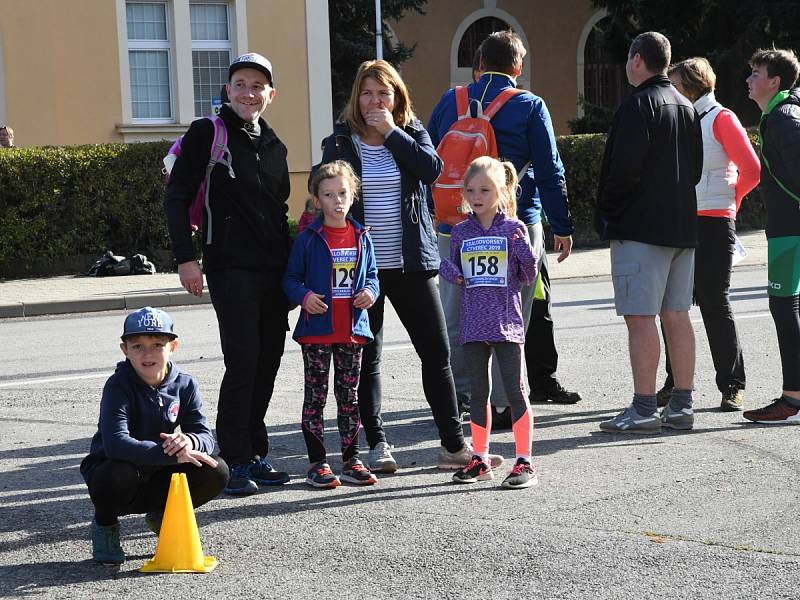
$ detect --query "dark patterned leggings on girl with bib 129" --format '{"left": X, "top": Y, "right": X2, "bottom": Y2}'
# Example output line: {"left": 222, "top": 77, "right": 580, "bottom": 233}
{"left": 302, "top": 344, "right": 361, "bottom": 464}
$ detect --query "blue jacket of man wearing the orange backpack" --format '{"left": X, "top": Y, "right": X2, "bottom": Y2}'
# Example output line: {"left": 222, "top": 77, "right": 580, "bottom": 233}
{"left": 428, "top": 72, "right": 573, "bottom": 236}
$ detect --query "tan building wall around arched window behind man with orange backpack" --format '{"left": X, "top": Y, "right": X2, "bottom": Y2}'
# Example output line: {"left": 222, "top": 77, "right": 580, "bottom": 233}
{"left": 391, "top": 0, "right": 595, "bottom": 135}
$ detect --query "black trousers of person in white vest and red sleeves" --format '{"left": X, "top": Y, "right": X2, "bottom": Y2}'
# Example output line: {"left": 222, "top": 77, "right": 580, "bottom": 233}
{"left": 664, "top": 216, "right": 745, "bottom": 392}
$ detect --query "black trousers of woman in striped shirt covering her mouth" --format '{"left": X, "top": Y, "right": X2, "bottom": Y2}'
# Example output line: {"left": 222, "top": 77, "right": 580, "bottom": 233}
{"left": 358, "top": 269, "right": 464, "bottom": 452}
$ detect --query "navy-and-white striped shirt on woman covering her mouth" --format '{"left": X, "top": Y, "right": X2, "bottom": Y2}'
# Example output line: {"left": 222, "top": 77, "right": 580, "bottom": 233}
{"left": 359, "top": 142, "right": 403, "bottom": 269}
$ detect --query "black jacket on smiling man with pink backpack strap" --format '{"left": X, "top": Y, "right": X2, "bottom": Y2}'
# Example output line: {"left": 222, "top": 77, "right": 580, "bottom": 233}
{"left": 164, "top": 105, "right": 291, "bottom": 273}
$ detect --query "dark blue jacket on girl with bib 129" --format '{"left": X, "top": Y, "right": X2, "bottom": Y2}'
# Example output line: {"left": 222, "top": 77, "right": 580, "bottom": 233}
{"left": 283, "top": 217, "right": 380, "bottom": 340}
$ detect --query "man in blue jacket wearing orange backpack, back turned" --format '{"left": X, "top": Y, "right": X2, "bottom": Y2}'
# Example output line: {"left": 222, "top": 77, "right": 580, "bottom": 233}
{"left": 428, "top": 31, "right": 581, "bottom": 427}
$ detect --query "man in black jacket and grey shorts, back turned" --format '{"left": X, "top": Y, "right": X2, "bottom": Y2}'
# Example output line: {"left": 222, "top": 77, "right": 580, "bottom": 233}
{"left": 596, "top": 32, "right": 703, "bottom": 433}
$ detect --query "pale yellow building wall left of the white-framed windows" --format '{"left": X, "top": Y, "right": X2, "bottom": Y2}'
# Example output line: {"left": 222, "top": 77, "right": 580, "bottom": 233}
{"left": 0, "top": 0, "right": 122, "bottom": 146}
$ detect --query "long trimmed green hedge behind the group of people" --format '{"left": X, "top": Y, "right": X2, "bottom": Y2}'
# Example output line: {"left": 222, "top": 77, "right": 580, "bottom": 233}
{"left": 0, "top": 134, "right": 765, "bottom": 278}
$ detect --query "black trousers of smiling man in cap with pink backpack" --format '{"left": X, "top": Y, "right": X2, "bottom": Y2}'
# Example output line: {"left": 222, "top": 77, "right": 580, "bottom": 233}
{"left": 206, "top": 269, "right": 289, "bottom": 465}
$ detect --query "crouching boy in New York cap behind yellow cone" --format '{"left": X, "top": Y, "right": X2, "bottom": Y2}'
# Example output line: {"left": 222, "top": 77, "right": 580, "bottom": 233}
{"left": 81, "top": 306, "right": 228, "bottom": 563}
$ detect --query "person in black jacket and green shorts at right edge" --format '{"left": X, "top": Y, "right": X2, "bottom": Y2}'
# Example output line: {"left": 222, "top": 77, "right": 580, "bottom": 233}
{"left": 744, "top": 48, "right": 800, "bottom": 423}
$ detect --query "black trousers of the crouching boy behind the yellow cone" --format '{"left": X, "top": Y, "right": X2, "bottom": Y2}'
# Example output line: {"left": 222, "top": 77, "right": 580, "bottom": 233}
{"left": 87, "top": 457, "right": 228, "bottom": 526}
